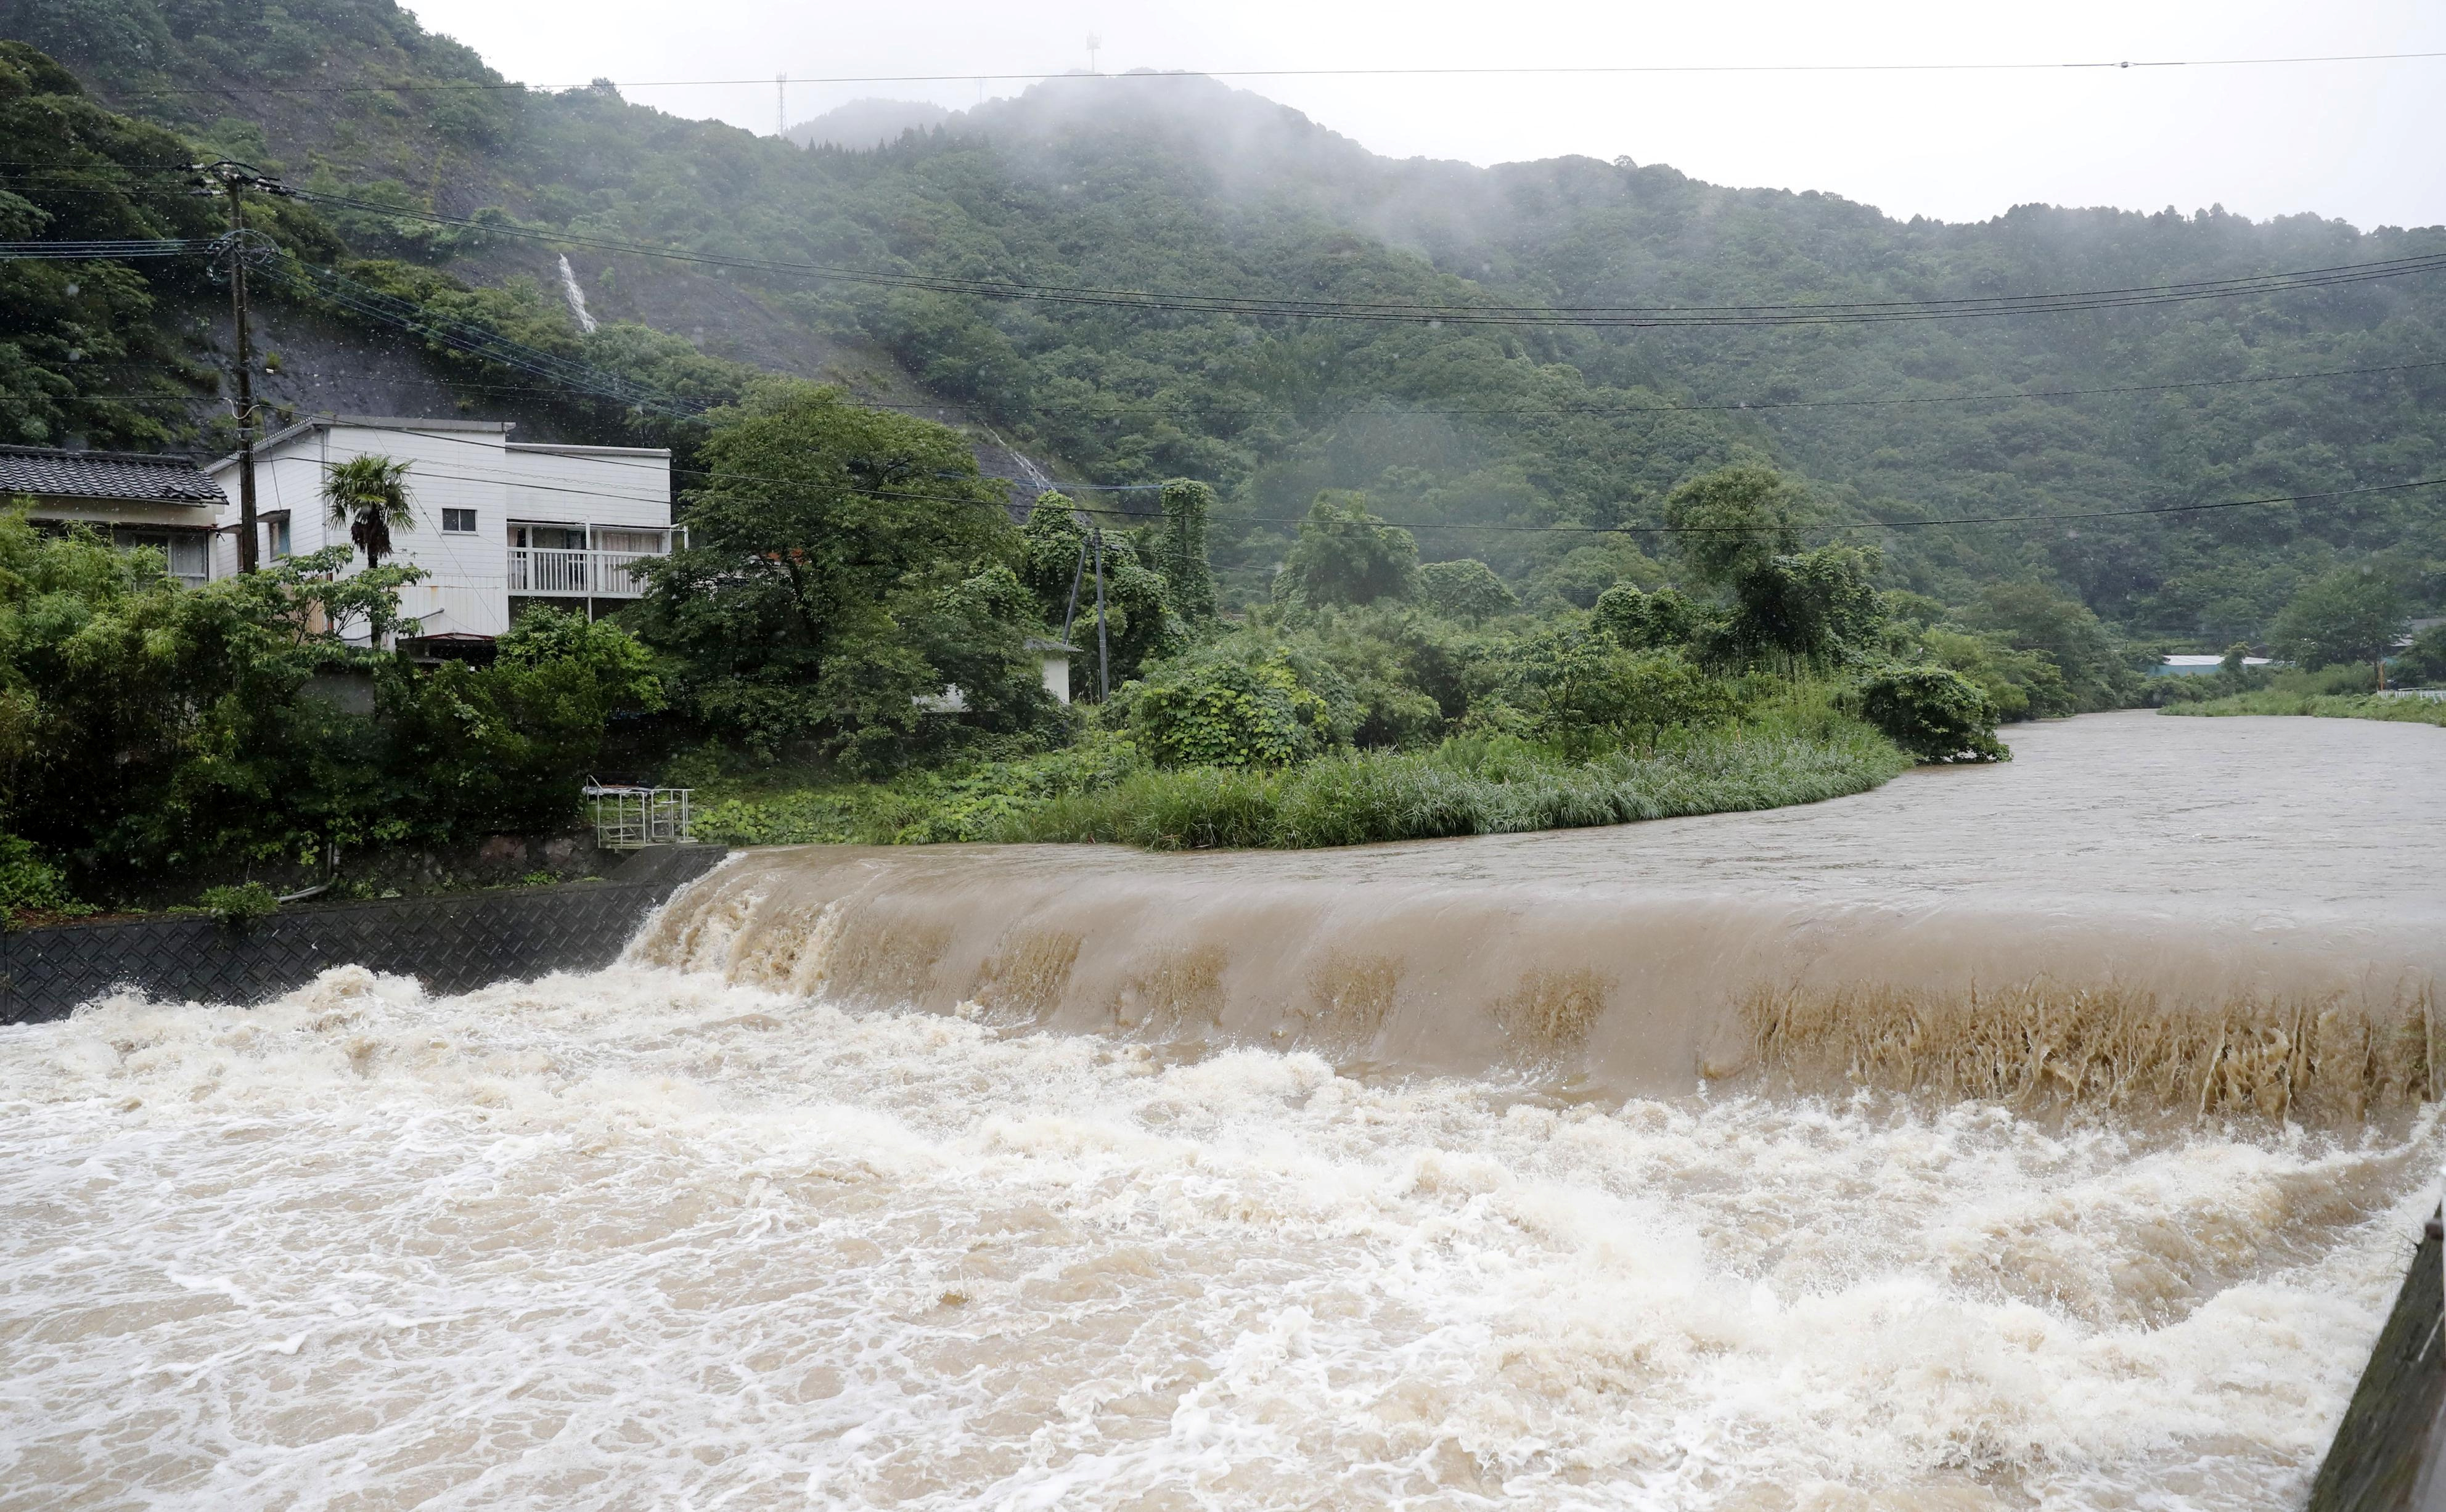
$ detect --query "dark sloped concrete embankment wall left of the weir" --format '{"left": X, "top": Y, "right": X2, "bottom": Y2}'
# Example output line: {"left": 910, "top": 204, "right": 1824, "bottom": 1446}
{"left": 0, "top": 844, "right": 729, "bottom": 1023}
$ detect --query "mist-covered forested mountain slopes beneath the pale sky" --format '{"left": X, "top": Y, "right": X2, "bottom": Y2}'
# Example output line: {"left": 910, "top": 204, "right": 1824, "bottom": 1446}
{"left": 0, "top": 0, "right": 2446, "bottom": 646}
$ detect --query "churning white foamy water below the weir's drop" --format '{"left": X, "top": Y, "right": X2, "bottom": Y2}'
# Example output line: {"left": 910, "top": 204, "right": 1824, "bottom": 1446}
{"left": 0, "top": 964, "right": 2436, "bottom": 1512}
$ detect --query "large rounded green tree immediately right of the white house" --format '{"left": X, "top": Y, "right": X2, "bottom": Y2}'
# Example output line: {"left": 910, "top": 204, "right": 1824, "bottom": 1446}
{"left": 631, "top": 384, "right": 1044, "bottom": 770}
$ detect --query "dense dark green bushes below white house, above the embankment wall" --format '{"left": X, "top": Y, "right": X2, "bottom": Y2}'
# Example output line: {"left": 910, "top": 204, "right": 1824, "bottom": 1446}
{"left": 0, "top": 514, "right": 658, "bottom": 908}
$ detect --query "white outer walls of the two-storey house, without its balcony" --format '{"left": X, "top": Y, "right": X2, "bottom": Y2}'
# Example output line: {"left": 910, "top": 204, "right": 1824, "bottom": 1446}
{"left": 213, "top": 419, "right": 670, "bottom": 636}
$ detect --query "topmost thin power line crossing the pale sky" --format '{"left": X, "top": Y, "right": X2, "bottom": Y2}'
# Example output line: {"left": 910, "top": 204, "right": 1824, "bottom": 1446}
{"left": 105, "top": 51, "right": 2446, "bottom": 100}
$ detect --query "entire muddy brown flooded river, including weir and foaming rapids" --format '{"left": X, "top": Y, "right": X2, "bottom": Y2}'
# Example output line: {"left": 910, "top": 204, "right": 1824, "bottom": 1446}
{"left": 0, "top": 714, "right": 2446, "bottom": 1512}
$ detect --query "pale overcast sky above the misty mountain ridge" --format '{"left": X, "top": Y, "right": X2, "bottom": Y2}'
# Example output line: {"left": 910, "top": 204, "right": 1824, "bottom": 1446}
{"left": 406, "top": 0, "right": 2446, "bottom": 227}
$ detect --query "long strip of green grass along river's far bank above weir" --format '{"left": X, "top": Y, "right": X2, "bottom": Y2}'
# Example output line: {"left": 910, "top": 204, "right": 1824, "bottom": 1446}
{"left": 697, "top": 700, "right": 1910, "bottom": 849}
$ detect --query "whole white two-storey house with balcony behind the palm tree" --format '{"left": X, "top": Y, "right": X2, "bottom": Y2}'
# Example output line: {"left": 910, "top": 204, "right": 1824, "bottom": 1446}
{"left": 208, "top": 416, "right": 677, "bottom": 641}
